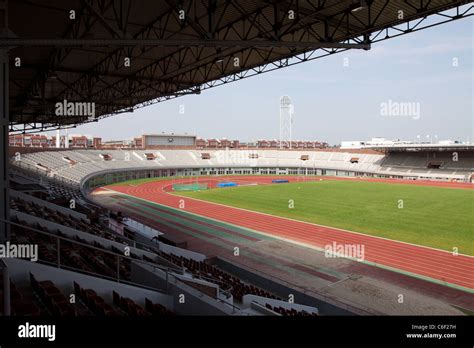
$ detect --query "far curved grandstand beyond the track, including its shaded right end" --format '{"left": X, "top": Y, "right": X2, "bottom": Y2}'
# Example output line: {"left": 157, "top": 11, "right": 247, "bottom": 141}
{"left": 12, "top": 149, "right": 474, "bottom": 187}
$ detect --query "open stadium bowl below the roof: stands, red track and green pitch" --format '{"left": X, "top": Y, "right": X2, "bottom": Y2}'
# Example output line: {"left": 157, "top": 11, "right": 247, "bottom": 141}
{"left": 4, "top": 138, "right": 474, "bottom": 314}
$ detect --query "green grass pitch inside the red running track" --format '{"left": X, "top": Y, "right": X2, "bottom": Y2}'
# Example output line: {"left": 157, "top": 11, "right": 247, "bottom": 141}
{"left": 175, "top": 180, "right": 474, "bottom": 255}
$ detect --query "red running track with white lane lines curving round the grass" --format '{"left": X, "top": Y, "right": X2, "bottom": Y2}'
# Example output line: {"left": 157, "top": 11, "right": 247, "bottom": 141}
{"left": 103, "top": 176, "right": 474, "bottom": 290}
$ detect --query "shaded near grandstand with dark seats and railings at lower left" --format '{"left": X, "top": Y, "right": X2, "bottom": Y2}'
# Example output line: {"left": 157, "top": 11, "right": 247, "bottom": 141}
{"left": 2, "top": 182, "right": 317, "bottom": 316}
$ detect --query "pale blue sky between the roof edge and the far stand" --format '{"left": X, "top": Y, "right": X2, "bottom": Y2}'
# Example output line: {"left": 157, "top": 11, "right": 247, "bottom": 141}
{"left": 69, "top": 10, "right": 474, "bottom": 144}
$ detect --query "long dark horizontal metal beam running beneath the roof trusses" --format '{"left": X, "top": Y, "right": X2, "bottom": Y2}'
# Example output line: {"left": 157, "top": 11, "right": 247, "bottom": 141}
{"left": 0, "top": 38, "right": 370, "bottom": 49}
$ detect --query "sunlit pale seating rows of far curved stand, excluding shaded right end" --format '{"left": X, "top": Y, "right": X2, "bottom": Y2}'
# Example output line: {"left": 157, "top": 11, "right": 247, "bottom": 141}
{"left": 12, "top": 149, "right": 394, "bottom": 185}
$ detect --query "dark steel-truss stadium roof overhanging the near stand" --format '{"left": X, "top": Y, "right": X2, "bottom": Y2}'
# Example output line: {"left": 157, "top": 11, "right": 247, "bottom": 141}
{"left": 0, "top": 0, "right": 473, "bottom": 132}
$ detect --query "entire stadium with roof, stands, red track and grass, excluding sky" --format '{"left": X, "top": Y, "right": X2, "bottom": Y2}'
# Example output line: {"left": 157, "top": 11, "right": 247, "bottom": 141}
{"left": 0, "top": 0, "right": 474, "bottom": 346}
